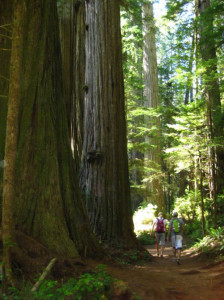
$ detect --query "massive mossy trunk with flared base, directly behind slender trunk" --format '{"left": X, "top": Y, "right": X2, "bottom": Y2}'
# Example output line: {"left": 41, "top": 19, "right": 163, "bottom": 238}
{"left": 5, "top": 0, "right": 97, "bottom": 257}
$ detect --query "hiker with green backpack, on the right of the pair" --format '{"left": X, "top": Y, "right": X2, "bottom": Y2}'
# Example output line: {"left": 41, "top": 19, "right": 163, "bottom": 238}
{"left": 167, "top": 211, "right": 185, "bottom": 264}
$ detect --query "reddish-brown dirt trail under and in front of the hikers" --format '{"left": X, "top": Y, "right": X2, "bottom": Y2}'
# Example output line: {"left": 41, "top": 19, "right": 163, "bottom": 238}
{"left": 88, "top": 244, "right": 224, "bottom": 300}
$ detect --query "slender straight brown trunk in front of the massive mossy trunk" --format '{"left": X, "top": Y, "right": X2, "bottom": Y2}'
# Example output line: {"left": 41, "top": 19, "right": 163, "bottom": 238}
{"left": 2, "top": 1, "right": 24, "bottom": 286}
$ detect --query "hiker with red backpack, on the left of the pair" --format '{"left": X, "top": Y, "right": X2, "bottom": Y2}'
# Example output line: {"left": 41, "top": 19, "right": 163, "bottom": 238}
{"left": 151, "top": 212, "right": 167, "bottom": 257}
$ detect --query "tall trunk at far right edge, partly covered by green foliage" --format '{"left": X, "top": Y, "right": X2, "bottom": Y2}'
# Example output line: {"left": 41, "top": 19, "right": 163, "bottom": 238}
{"left": 196, "top": 0, "right": 224, "bottom": 227}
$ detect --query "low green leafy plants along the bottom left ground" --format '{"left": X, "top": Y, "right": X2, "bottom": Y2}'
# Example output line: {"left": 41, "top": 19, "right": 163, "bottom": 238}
{"left": 0, "top": 265, "right": 115, "bottom": 300}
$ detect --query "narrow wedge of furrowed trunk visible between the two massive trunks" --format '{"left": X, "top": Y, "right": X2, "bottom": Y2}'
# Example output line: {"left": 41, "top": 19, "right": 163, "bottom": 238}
{"left": 58, "top": 0, "right": 86, "bottom": 172}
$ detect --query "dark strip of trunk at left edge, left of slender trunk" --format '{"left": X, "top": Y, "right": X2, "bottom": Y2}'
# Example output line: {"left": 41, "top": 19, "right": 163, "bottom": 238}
{"left": 0, "top": 0, "right": 12, "bottom": 216}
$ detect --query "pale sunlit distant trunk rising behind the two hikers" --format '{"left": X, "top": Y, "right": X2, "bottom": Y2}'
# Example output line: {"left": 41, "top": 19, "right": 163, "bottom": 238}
{"left": 142, "top": 1, "right": 165, "bottom": 211}
